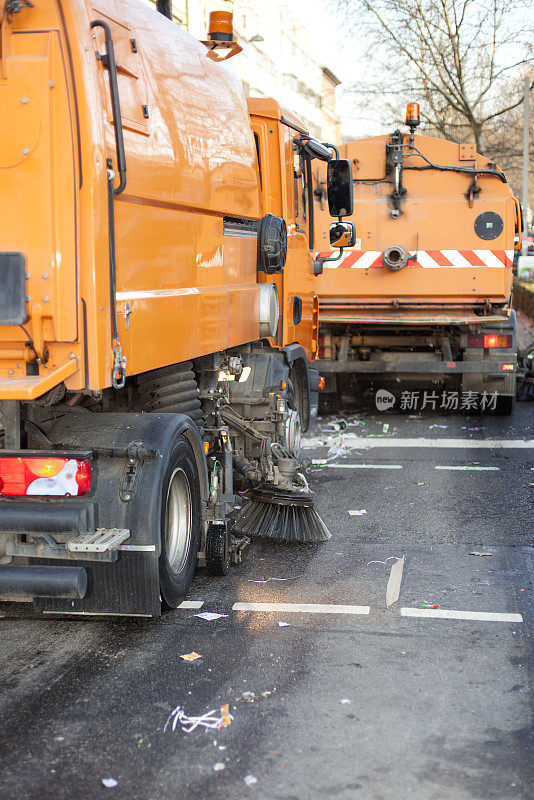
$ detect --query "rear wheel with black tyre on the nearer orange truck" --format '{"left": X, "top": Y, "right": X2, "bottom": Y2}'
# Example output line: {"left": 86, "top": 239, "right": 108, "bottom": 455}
{"left": 159, "top": 438, "right": 200, "bottom": 608}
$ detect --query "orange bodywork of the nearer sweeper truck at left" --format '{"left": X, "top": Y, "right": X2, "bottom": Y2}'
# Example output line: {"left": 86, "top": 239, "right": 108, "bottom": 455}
{"left": 0, "top": 0, "right": 314, "bottom": 400}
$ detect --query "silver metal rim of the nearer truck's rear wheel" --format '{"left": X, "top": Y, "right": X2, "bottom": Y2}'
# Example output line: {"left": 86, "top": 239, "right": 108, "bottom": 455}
{"left": 165, "top": 467, "right": 192, "bottom": 575}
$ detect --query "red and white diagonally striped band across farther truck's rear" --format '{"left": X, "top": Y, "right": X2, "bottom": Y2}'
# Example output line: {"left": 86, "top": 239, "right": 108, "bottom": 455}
{"left": 317, "top": 250, "right": 514, "bottom": 269}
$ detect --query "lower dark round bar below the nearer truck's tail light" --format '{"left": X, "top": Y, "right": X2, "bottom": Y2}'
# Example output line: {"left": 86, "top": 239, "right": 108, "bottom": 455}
{"left": 0, "top": 564, "right": 87, "bottom": 601}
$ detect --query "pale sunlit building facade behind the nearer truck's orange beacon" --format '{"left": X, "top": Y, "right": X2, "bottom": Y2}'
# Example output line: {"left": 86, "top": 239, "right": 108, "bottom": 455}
{"left": 138, "top": 0, "right": 340, "bottom": 144}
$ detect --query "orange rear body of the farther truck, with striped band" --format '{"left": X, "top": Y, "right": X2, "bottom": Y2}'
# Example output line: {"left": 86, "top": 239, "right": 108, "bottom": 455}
{"left": 315, "top": 134, "right": 520, "bottom": 410}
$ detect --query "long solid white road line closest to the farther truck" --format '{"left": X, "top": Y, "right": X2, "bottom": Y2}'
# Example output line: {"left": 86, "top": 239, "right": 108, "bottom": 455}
{"left": 302, "top": 434, "right": 534, "bottom": 450}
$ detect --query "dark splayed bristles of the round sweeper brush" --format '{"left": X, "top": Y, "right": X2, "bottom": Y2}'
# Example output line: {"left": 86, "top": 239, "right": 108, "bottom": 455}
{"left": 234, "top": 498, "right": 331, "bottom": 543}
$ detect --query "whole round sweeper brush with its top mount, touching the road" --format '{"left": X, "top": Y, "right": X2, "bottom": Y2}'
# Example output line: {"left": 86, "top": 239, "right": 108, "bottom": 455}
{"left": 234, "top": 485, "right": 331, "bottom": 544}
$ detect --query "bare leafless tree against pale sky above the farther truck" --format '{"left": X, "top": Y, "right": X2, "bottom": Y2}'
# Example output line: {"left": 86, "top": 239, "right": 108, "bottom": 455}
{"left": 337, "top": 0, "right": 534, "bottom": 153}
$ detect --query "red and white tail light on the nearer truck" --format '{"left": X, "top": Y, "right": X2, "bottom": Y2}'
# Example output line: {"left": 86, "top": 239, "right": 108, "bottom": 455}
{"left": 0, "top": 456, "right": 91, "bottom": 497}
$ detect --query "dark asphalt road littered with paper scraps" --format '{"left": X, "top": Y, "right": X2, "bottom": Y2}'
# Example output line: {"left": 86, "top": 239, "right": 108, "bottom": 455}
{"left": 0, "top": 403, "right": 534, "bottom": 800}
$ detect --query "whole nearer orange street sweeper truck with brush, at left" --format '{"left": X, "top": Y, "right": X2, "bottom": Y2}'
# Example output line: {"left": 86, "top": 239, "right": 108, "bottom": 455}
{"left": 0, "top": 0, "right": 352, "bottom": 615}
